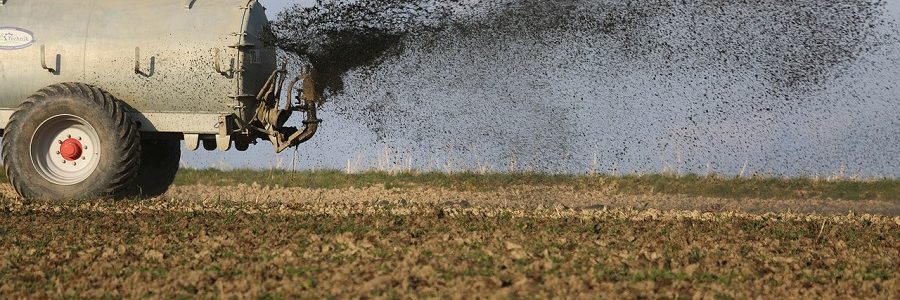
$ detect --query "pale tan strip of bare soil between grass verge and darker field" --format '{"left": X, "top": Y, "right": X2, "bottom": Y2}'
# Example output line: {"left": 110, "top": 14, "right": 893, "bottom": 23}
{"left": 171, "top": 184, "right": 900, "bottom": 216}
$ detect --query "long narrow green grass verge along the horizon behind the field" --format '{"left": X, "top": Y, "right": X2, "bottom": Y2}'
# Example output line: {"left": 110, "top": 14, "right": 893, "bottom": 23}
{"left": 175, "top": 169, "right": 900, "bottom": 201}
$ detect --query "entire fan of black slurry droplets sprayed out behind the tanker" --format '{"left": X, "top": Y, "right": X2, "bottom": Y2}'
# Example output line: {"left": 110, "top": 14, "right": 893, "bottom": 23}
{"left": 273, "top": 0, "right": 900, "bottom": 174}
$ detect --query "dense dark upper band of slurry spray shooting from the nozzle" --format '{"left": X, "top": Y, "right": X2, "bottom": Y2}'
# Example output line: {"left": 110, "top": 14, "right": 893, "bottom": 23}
{"left": 272, "top": 0, "right": 884, "bottom": 98}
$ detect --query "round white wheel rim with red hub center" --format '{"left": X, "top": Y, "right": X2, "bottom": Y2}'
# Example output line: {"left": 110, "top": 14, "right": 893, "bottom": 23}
{"left": 30, "top": 115, "right": 100, "bottom": 185}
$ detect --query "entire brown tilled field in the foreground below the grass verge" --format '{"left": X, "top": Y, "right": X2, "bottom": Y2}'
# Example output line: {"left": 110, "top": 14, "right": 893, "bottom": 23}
{"left": 0, "top": 185, "right": 900, "bottom": 299}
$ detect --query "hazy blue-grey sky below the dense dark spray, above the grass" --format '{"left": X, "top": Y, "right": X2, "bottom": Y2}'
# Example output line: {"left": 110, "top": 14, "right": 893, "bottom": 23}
{"left": 183, "top": 0, "right": 900, "bottom": 177}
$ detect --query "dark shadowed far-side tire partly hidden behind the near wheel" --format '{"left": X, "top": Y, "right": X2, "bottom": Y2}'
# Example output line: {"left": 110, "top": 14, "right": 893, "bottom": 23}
{"left": 128, "top": 140, "right": 181, "bottom": 198}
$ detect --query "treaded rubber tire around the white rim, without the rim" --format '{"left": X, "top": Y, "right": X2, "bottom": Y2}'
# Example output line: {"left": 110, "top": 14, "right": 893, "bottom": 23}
{"left": 2, "top": 83, "right": 141, "bottom": 200}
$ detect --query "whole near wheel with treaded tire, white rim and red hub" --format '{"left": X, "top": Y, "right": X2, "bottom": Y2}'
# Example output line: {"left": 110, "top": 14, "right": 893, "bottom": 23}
{"left": 2, "top": 83, "right": 141, "bottom": 200}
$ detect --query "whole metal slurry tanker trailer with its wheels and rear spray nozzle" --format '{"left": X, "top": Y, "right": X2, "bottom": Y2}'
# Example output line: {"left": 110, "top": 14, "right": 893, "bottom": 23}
{"left": 0, "top": 0, "right": 321, "bottom": 199}
